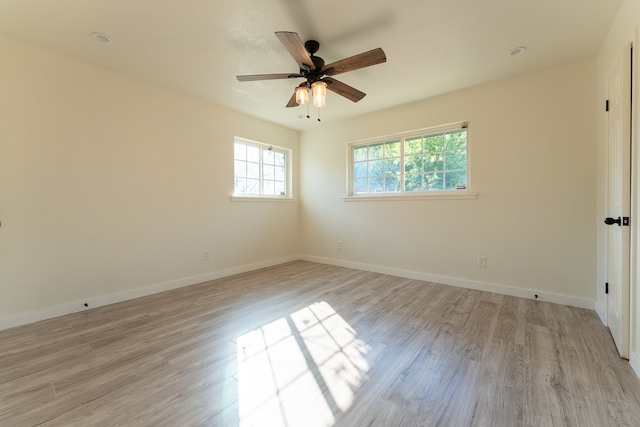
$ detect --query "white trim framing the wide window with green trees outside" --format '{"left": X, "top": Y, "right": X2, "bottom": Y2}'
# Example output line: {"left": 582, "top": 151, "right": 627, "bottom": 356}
{"left": 342, "top": 121, "right": 478, "bottom": 202}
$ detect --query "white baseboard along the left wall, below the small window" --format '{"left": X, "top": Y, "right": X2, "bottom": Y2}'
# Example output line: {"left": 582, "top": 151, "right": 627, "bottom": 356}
{"left": 0, "top": 256, "right": 299, "bottom": 330}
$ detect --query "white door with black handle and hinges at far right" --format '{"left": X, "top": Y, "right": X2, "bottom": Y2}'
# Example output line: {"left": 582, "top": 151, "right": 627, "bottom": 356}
{"left": 605, "top": 45, "right": 631, "bottom": 359}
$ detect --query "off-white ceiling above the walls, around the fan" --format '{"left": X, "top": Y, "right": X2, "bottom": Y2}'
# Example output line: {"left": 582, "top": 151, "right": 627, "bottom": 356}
{"left": 0, "top": 0, "right": 622, "bottom": 129}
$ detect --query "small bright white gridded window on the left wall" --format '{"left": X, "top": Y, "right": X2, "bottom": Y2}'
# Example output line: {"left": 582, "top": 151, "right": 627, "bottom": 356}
{"left": 233, "top": 138, "right": 289, "bottom": 198}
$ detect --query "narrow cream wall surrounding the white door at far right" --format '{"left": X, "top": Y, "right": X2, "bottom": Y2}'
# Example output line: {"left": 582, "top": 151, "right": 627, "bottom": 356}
{"left": 596, "top": 0, "right": 640, "bottom": 375}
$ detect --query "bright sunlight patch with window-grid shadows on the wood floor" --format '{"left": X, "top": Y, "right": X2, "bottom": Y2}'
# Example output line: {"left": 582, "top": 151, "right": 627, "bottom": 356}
{"left": 237, "top": 302, "right": 369, "bottom": 426}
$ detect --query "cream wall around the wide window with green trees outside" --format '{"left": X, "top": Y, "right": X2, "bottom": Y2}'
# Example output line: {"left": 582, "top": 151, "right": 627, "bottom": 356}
{"left": 300, "top": 60, "right": 596, "bottom": 308}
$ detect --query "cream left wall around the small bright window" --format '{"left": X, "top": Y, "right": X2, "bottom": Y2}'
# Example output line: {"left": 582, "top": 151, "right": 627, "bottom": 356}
{"left": 0, "top": 39, "right": 299, "bottom": 327}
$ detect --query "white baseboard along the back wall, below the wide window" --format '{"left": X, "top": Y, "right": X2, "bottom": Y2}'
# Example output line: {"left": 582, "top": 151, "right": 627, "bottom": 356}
{"left": 300, "top": 255, "right": 595, "bottom": 310}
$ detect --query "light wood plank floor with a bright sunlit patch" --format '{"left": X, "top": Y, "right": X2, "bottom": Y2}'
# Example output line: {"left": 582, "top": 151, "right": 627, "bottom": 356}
{"left": 0, "top": 261, "right": 640, "bottom": 427}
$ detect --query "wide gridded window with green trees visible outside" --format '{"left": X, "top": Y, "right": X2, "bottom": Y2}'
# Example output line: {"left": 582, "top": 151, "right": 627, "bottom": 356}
{"left": 349, "top": 124, "right": 468, "bottom": 195}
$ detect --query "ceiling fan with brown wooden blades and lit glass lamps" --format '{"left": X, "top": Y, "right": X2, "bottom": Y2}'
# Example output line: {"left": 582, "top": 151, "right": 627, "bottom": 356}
{"left": 236, "top": 31, "right": 387, "bottom": 107}
